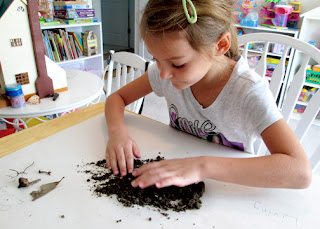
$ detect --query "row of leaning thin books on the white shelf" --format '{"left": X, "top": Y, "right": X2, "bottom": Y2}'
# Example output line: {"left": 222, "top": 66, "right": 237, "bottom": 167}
{"left": 42, "top": 29, "right": 83, "bottom": 62}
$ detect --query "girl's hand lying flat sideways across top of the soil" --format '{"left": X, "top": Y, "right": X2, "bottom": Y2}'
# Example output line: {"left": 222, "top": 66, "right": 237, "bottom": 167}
{"left": 131, "top": 157, "right": 204, "bottom": 188}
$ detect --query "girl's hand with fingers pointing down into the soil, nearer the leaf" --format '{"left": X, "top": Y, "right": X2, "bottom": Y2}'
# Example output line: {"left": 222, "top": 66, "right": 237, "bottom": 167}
{"left": 106, "top": 134, "right": 140, "bottom": 176}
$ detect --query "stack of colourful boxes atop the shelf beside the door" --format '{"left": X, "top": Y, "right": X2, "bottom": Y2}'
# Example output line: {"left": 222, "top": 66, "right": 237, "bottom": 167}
{"left": 53, "top": 1, "right": 98, "bottom": 24}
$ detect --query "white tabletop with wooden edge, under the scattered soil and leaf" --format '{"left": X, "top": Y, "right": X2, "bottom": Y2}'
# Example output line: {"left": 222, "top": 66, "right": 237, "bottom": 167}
{"left": 0, "top": 112, "right": 320, "bottom": 229}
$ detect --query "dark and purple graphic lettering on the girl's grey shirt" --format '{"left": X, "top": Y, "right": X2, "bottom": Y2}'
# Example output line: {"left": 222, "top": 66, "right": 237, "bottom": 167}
{"left": 169, "top": 104, "right": 244, "bottom": 151}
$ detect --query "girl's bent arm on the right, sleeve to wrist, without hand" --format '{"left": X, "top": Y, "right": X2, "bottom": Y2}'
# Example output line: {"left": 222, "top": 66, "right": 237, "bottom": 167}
{"left": 204, "top": 119, "right": 312, "bottom": 188}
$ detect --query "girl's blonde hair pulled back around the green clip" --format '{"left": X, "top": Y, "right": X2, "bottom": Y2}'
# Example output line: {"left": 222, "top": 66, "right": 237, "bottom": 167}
{"left": 140, "top": 0, "right": 239, "bottom": 59}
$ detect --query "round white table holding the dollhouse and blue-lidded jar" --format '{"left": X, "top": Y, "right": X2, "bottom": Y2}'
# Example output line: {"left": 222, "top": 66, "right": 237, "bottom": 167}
{"left": 0, "top": 69, "right": 103, "bottom": 129}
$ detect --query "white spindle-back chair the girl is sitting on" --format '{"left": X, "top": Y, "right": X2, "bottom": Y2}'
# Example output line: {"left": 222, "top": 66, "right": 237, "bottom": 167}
{"left": 238, "top": 33, "right": 320, "bottom": 172}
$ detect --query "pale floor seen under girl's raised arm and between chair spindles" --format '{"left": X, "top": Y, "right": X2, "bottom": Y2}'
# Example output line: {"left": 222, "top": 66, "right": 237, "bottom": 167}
{"left": 142, "top": 93, "right": 320, "bottom": 175}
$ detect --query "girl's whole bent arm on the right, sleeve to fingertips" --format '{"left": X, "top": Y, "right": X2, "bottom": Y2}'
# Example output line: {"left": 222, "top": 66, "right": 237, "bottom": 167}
{"left": 132, "top": 119, "right": 312, "bottom": 188}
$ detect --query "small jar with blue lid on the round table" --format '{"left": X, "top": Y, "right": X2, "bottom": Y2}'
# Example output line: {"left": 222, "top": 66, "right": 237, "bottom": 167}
{"left": 5, "top": 83, "right": 26, "bottom": 108}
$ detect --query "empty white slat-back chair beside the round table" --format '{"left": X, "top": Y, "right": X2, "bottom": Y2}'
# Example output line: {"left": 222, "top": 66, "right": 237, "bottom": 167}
{"left": 103, "top": 50, "right": 149, "bottom": 113}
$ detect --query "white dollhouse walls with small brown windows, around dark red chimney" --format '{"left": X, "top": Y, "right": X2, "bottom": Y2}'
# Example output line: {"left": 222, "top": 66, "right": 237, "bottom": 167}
{"left": 0, "top": 0, "right": 68, "bottom": 107}
